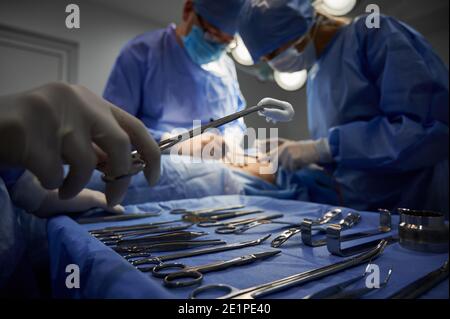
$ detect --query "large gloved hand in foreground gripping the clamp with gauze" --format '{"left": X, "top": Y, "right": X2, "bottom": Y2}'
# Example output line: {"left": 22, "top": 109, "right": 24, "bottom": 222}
{"left": 0, "top": 83, "right": 160, "bottom": 206}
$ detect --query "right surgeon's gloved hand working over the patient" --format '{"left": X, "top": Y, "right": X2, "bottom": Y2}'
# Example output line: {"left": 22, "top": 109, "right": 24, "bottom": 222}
{"left": 269, "top": 139, "right": 333, "bottom": 171}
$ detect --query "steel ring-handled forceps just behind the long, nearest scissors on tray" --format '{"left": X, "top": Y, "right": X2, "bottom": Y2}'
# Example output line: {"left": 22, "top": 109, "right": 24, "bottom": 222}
{"left": 152, "top": 250, "right": 281, "bottom": 288}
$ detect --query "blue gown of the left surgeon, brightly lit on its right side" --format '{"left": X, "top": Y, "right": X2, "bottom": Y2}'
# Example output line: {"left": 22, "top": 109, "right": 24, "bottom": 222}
{"left": 104, "top": 25, "right": 245, "bottom": 140}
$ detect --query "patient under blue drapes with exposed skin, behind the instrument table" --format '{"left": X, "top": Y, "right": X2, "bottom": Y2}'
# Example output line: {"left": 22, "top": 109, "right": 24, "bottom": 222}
{"left": 88, "top": 155, "right": 336, "bottom": 205}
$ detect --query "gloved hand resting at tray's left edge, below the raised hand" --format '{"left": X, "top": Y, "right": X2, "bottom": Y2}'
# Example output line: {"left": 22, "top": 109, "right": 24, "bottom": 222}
{"left": 11, "top": 171, "right": 124, "bottom": 218}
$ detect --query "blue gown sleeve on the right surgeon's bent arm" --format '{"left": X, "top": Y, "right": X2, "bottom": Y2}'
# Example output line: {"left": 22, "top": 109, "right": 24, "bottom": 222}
{"left": 329, "top": 19, "right": 449, "bottom": 171}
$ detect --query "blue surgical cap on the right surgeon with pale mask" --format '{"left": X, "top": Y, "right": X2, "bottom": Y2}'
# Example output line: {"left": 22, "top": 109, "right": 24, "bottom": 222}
{"left": 239, "top": 0, "right": 314, "bottom": 62}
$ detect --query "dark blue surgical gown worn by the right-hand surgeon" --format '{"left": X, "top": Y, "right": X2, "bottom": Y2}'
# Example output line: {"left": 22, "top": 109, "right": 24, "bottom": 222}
{"left": 307, "top": 16, "right": 449, "bottom": 212}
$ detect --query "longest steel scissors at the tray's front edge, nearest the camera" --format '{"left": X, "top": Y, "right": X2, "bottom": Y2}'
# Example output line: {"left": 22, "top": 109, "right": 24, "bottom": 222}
{"left": 190, "top": 240, "right": 386, "bottom": 299}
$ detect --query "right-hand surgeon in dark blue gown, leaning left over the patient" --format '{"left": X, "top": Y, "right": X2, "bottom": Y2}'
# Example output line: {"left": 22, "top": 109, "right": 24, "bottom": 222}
{"left": 240, "top": 0, "right": 449, "bottom": 213}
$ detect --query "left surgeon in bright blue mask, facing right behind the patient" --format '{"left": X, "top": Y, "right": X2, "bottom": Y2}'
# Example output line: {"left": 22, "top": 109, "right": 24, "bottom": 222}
{"left": 104, "top": 0, "right": 245, "bottom": 154}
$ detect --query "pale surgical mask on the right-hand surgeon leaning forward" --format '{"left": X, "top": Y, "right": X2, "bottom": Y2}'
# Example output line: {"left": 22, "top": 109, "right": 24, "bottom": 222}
{"left": 268, "top": 39, "right": 317, "bottom": 73}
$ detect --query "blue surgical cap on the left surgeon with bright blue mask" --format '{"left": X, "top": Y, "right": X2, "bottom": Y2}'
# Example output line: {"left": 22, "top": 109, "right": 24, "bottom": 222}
{"left": 194, "top": 0, "right": 246, "bottom": 35}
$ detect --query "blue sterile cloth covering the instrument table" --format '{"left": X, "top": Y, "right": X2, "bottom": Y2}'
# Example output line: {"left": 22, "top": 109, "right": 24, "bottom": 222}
{"left": 48, "top": 196, "right": 448, "bottom": 298}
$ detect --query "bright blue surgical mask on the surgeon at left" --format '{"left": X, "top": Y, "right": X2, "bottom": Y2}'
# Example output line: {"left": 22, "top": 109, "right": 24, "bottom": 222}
{"left": 183, "top": 25, "right": 227, "bottom": 65}
